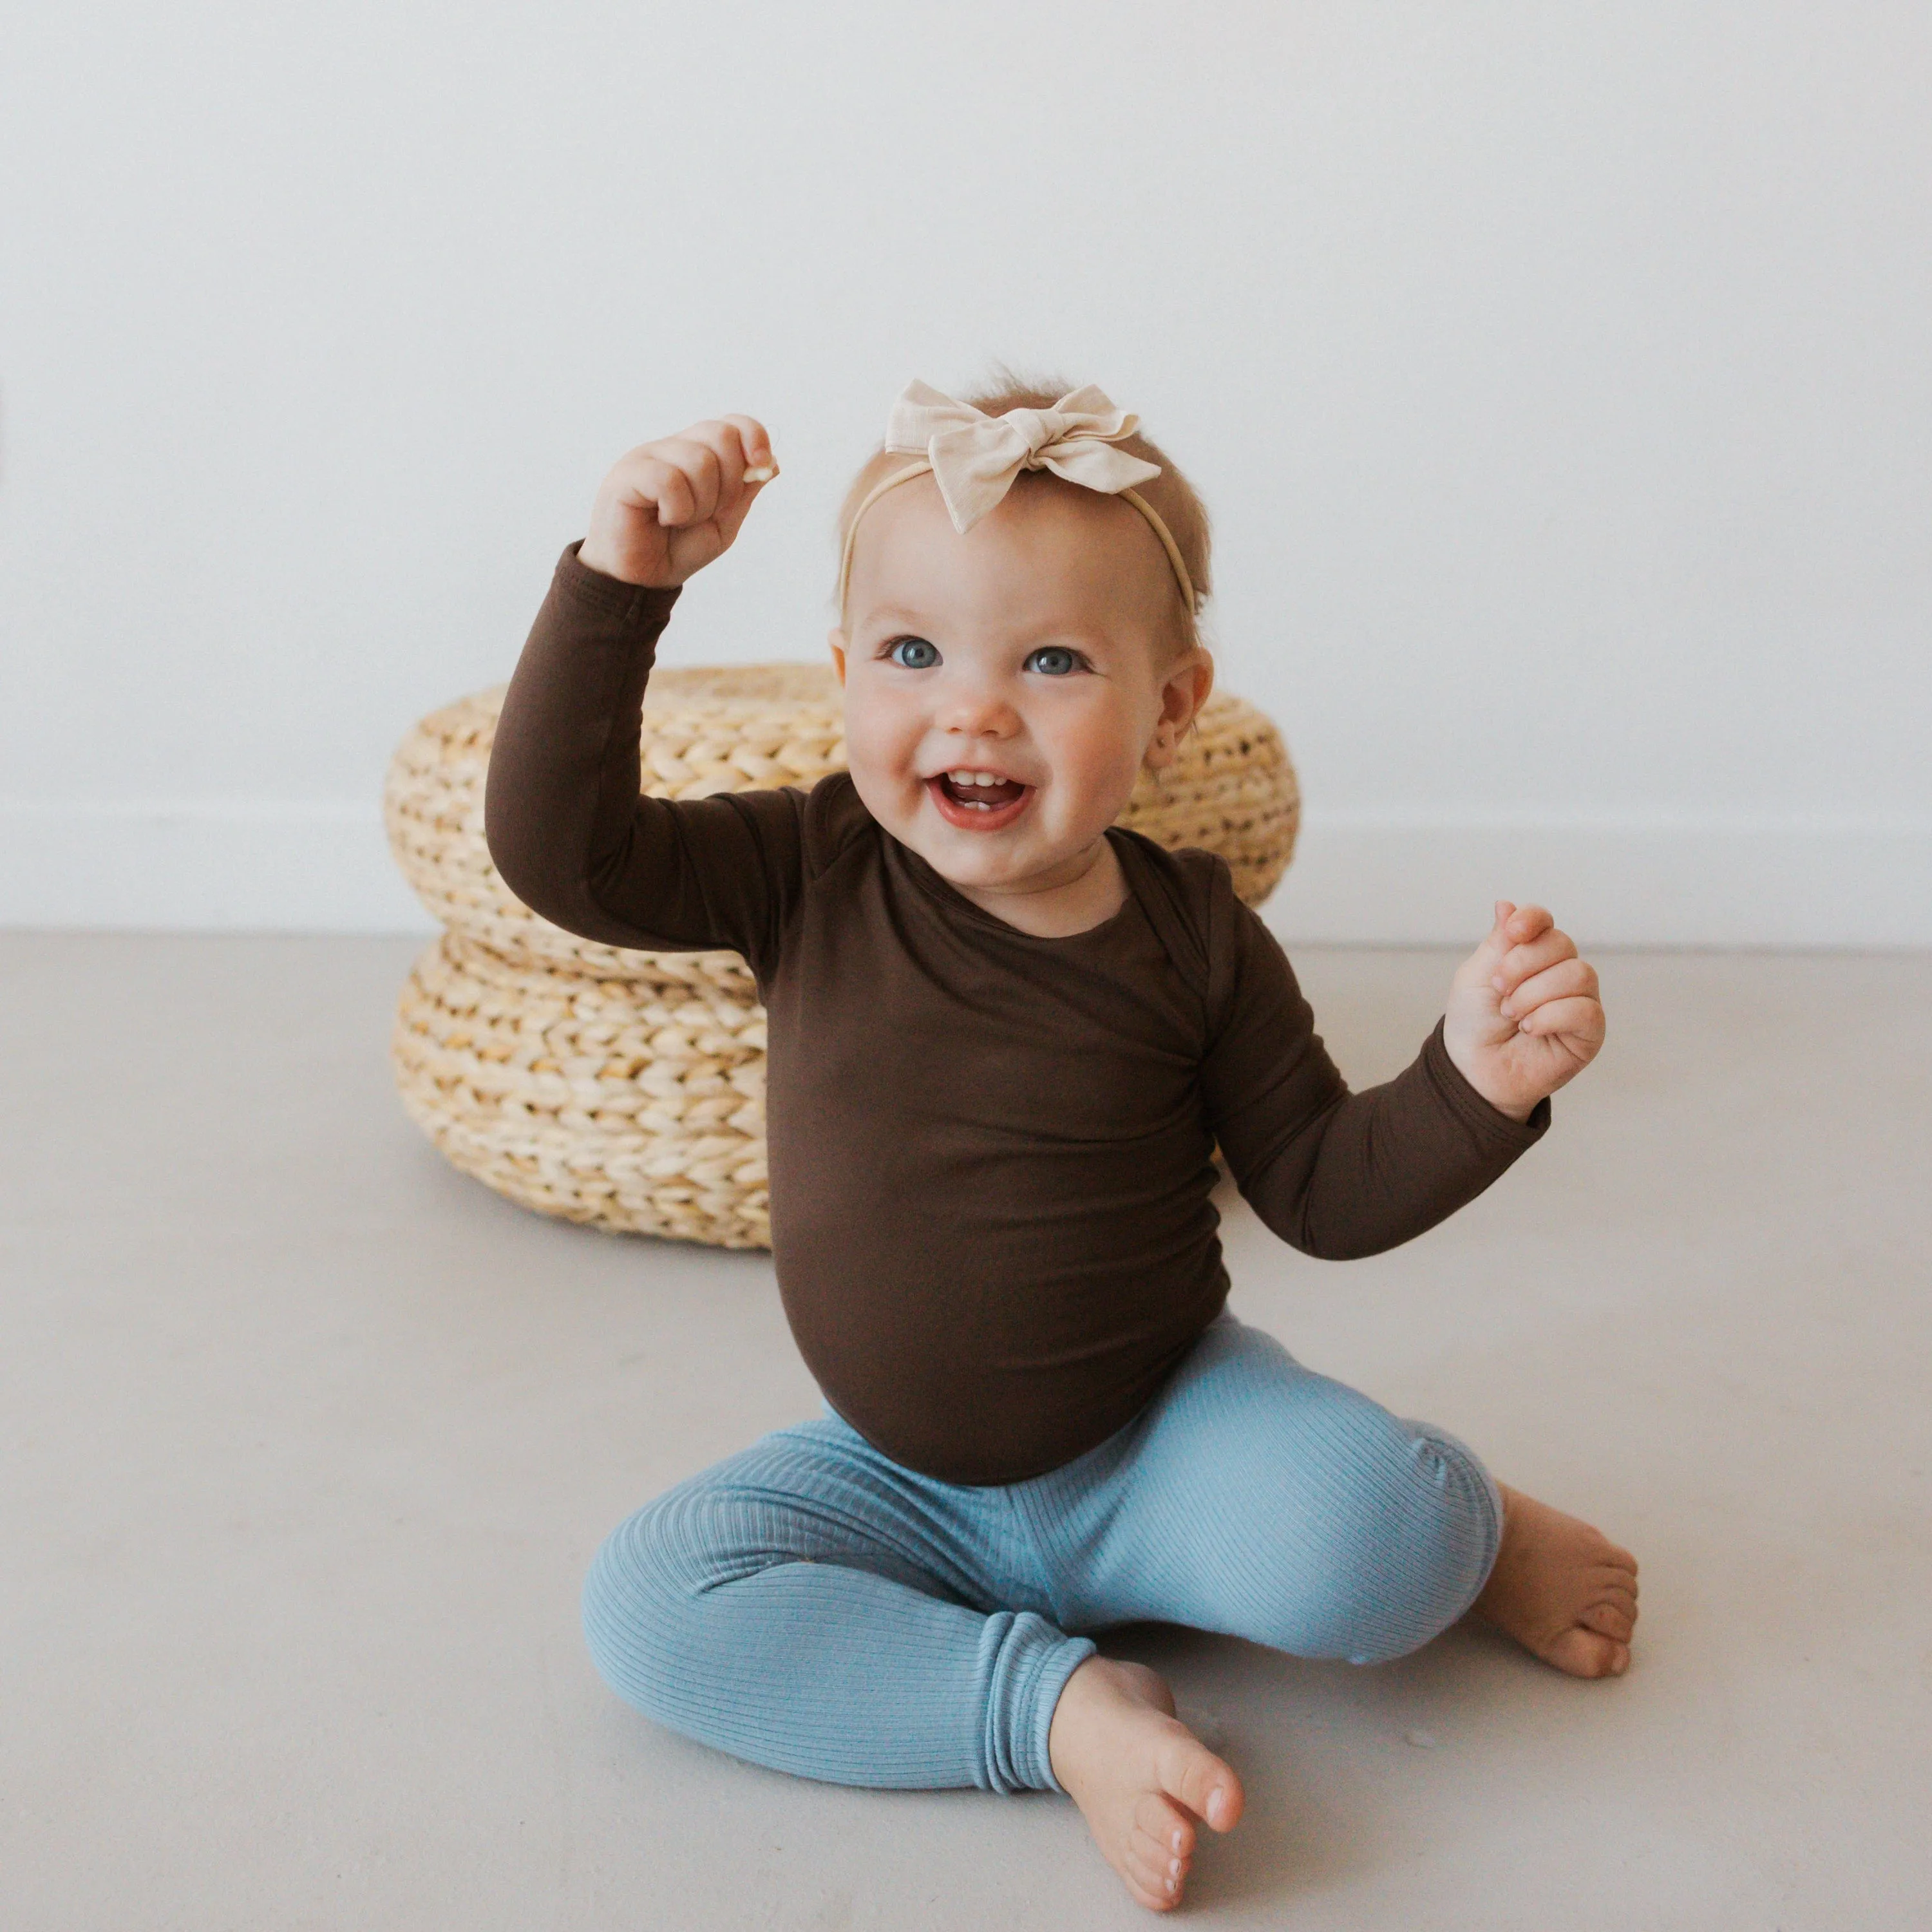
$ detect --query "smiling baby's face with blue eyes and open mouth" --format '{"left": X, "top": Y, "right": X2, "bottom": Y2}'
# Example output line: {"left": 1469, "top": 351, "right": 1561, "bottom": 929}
{"left": 831, "top": 475, "right": 1211, "bottom": 896}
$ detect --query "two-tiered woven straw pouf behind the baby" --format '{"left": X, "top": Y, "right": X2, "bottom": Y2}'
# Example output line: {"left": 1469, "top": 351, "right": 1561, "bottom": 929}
{"left": 383, "top": 665, "right": 1300, "bottom": 1248}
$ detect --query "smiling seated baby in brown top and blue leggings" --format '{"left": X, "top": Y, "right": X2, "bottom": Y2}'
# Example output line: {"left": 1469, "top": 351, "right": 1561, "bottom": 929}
{"left": 487, "top": 384, "right": 1636, "bottom": 1911}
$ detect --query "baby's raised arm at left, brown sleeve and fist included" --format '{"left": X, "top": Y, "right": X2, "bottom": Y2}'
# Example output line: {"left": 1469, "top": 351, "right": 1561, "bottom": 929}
{"left": 483, "top": 417, "right": 800, "bottom": 964}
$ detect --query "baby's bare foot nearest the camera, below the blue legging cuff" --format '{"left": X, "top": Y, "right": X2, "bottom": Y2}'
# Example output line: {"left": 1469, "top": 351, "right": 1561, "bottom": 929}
{"left": 1047, "top": 1658, "right": 1244, "bottom": 1913}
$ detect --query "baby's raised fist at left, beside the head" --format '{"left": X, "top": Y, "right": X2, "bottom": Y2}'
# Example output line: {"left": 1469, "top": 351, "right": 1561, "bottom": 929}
{"left": 578, "top": 415, "right": 779, "bottom": 585}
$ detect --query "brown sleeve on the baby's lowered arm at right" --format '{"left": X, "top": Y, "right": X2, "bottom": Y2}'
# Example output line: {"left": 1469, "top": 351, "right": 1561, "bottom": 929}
{"left": 1202, "top": 895, "right": 1549, "bottom": 1260}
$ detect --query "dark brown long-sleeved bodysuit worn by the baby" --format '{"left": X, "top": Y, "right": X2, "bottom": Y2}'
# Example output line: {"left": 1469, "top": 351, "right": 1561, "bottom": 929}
{"left": 485, "top": 545, "right": 1549, "bottom": 1484}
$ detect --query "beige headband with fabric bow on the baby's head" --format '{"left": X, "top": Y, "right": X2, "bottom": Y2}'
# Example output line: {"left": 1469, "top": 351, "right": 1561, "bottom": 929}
{"left": 838, "top": 381, "right": 1200, "bottom": 614}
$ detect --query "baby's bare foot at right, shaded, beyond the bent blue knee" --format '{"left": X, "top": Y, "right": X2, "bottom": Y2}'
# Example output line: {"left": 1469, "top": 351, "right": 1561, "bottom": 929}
{"left": 1476, "top": 1490, "right": 1636, "bottom": 1677}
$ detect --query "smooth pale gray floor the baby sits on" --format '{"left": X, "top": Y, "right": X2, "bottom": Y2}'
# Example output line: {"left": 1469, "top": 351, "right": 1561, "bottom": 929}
{"left": 0, "top": 935, "right": 1932, "bottom": 1932}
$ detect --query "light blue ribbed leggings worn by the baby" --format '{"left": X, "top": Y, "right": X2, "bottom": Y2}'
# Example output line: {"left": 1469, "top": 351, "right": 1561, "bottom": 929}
{"left": 583, "top": 1312, "right": 1503, "bottom": 1791}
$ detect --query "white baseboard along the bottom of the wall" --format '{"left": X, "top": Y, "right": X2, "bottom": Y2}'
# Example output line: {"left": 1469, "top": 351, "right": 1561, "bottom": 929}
{"left": 0, "top": 802, "right": 1932, "bottom": 949}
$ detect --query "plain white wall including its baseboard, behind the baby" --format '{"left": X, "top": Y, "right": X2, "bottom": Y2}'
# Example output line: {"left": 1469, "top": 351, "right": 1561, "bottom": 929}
{"left": 0, "top": 0, "right": 1932, "bottom": 945}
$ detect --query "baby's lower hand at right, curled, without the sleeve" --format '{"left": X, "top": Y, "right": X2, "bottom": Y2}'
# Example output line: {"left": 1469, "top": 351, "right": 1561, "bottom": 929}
{"left": 1443, "top": 898, "right": 1604, "bottom": 1121}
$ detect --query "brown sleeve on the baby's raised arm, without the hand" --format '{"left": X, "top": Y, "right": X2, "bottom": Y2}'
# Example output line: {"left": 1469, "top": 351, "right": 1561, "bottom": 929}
{"left": 483, "top": 543, "right": 804, "bottom": 972}
